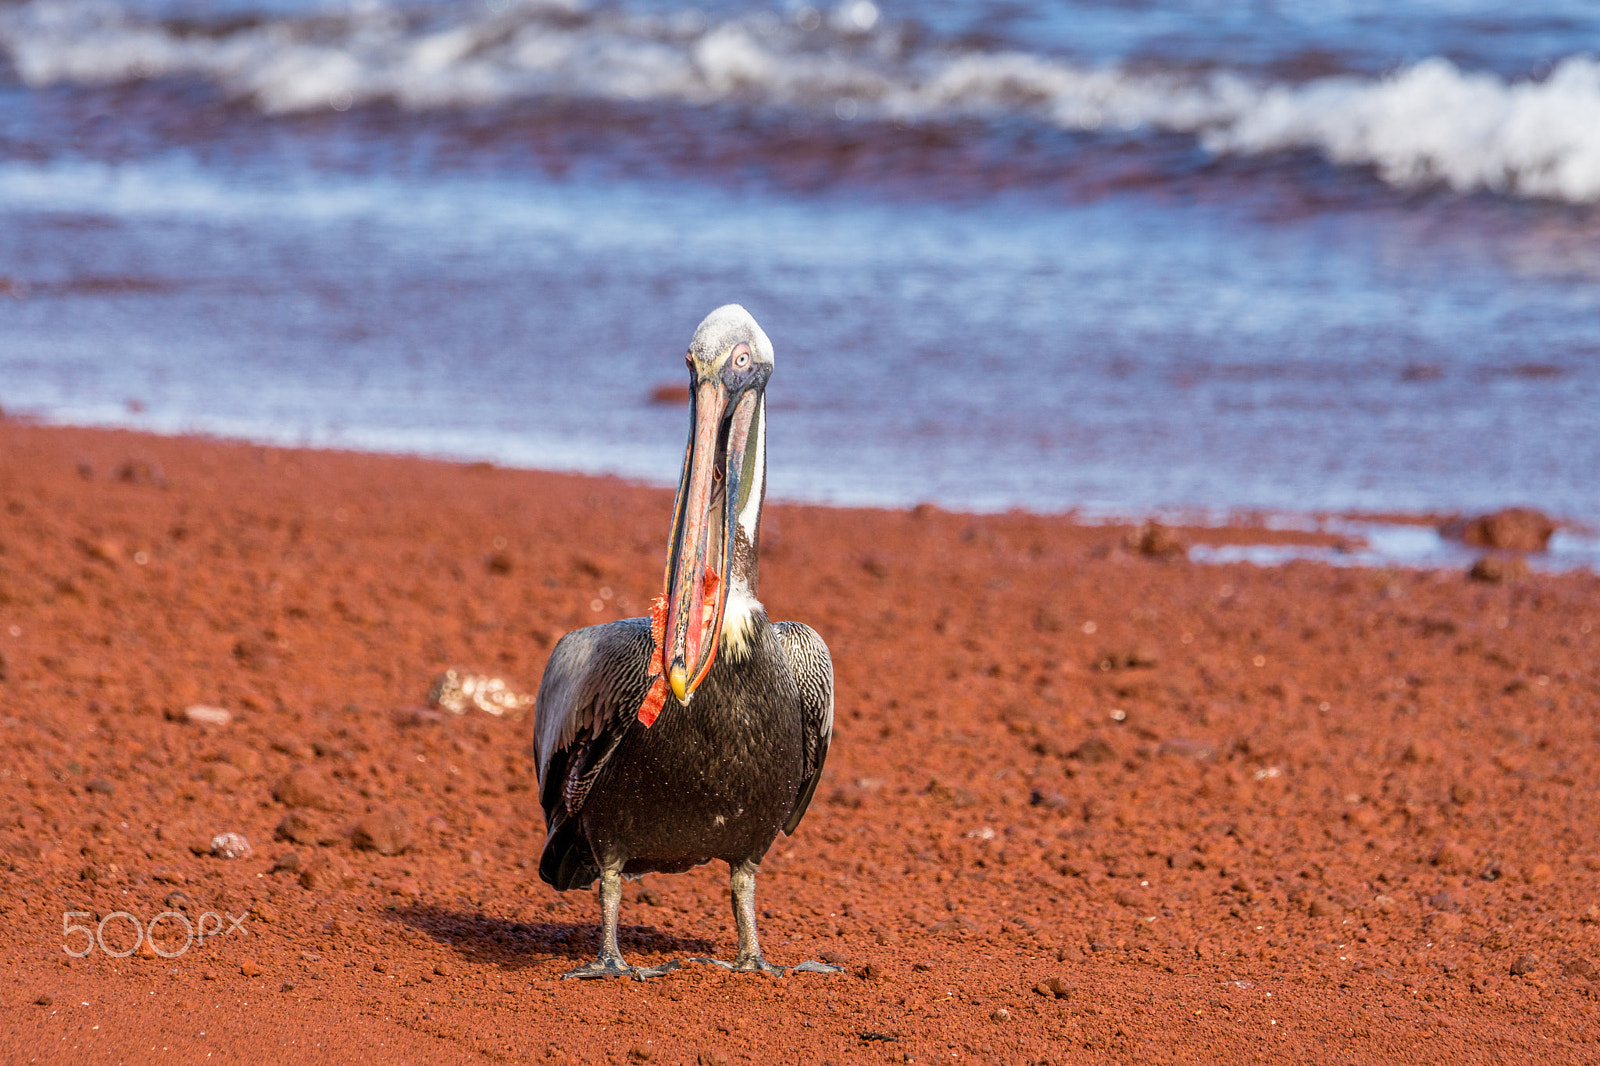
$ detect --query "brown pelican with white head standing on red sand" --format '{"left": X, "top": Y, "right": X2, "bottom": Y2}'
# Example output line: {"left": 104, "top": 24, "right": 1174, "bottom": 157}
{"left": 534, "top": 304, "right": 837, "bottom": 980}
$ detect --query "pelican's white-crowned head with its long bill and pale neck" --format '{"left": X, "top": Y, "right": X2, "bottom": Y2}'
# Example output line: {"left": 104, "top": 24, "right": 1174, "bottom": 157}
{"left": 661, "top": 304, "right": 773, "bottom": 704}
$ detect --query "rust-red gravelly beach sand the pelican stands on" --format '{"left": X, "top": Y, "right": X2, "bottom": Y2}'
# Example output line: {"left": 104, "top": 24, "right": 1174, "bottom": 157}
{"left": 0, "top": 421, "right": 1600, "bottom": 1064}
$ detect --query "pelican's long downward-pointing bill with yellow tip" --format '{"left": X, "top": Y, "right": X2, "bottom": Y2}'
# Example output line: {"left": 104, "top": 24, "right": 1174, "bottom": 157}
{"left": 661, "top": 375, "right": 760, "bottom": 704}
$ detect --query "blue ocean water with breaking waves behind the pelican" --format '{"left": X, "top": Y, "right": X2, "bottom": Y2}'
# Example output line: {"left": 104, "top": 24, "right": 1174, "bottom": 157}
{"left": 0, "top": 0, "right": 1600, "bottom": 557}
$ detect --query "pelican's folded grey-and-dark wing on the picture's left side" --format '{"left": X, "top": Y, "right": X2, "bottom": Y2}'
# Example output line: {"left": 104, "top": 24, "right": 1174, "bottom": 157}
{"left": 533, "top": 618, "right": 651, "bottom": 892}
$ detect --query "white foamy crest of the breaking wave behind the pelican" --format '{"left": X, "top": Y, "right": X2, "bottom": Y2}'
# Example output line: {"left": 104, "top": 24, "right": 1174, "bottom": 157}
{"left": 0, "top": 0, "right": 1600, "bottom": 202}
